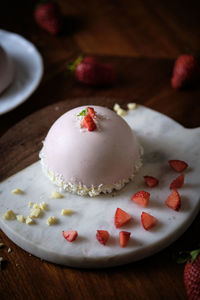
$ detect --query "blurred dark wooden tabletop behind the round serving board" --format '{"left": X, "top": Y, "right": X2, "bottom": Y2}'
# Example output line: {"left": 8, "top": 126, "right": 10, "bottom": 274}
{"left": 0, "top": 0, "right": 200, "bottom": 133}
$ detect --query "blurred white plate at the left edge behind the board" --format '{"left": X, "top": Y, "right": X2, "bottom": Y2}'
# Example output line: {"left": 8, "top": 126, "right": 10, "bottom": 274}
{"left": 0, "top": 30, "right": 43, "bottom": 115}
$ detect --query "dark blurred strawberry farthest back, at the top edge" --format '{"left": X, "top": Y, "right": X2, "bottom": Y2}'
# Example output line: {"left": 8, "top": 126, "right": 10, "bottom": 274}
{"left": 34, "top": 1, "right": 62, "bottom": 35}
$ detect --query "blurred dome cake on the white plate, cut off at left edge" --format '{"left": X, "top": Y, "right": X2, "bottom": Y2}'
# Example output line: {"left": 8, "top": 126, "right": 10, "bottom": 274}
{"left": 0, "top": 46, "right": 14, "bottom": 93}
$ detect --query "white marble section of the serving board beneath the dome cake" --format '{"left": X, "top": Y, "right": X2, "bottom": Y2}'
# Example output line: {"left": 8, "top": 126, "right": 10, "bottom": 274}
{"left": 0, "top": 106, "right": 200, "bottom": 268}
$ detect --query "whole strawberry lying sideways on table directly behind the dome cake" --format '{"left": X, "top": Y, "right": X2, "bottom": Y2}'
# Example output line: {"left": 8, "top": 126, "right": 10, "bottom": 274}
{"left": 68, "top": 56, "right": 116, "bottom": 86}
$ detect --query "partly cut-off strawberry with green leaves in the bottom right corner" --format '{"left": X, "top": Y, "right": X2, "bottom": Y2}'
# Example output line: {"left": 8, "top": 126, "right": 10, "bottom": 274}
{"left": 184, "top": 249, "right": 200, "bottom": 300}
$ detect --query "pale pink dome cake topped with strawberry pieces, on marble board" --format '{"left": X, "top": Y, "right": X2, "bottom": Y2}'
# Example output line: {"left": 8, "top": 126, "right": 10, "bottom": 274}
{"left": 40, "top": 106, "right": 141, "bottom": 196}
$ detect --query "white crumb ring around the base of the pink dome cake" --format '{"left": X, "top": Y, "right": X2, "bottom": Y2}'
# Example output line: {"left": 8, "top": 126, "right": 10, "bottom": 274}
{"left": 39, "top": 146, "right": 143, "bottom": 197}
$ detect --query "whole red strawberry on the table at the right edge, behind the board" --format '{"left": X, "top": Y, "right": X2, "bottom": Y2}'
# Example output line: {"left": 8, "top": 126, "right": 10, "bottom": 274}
{"left": 171, "top": 54, "right": 200, "bottom": 89}
